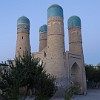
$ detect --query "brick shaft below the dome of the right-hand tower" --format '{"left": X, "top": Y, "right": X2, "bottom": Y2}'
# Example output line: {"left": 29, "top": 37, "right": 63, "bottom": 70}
{"left": 68, "top": 27, "right": 83, "bottom": 55}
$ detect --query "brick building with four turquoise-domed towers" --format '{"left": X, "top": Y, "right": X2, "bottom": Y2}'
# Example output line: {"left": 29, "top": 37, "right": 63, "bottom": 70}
{"left": 15, "top": 4, "right": 86, "bottom": 97}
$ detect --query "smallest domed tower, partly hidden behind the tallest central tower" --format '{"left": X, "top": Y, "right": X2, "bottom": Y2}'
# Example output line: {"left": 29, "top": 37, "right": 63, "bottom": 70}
{"left": 39, "top": 25, "right": 47, "bottom": 51}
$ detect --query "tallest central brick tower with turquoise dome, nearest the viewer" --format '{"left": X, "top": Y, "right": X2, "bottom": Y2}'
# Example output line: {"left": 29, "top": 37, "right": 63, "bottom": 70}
{"left": 46, "top": 4, "right": 67, "bottom": 93}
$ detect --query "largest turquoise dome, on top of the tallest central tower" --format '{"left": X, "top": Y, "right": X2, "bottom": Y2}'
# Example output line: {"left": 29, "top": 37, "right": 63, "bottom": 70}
{"left": 47, "top": 4, "right": 63, "bottom": 18}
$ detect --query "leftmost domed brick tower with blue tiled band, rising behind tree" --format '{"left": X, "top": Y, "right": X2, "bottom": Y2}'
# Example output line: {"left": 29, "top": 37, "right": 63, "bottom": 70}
{"left": 15, "top": 16, "right": 30, "bottom": 57}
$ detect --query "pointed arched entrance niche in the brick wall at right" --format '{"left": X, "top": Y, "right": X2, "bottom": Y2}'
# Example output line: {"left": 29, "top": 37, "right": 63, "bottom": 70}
{"left": 71, "top": 62, "right": 81, "bottom": 86}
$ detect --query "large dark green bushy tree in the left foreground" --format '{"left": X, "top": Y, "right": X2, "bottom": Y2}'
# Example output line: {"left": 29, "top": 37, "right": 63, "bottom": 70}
{"left": 0, "top": 53, "right": 56, "bottom": 100}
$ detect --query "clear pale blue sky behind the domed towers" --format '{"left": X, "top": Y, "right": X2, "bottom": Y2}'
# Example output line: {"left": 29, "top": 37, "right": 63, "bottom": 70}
{"left": 0, "top": 0, "right": 100, "bottom": 65}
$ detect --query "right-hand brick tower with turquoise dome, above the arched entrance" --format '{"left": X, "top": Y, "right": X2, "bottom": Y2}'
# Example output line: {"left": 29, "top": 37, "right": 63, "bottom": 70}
{"left": 68, "top": 16, "right": 83, "bottom": 55}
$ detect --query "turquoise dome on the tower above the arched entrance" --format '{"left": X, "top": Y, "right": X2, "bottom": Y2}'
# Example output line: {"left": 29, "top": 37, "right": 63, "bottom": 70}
{"left": 68, "top": 16, "right": 81, "bottom": 28}
